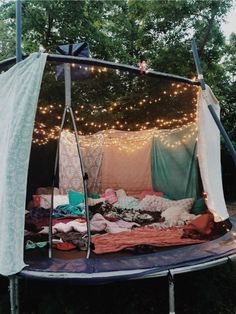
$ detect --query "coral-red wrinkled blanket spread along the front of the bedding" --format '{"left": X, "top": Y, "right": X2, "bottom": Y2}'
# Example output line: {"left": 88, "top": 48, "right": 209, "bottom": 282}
{"left": 92, "top": 227, "right": 206, "bottom": 254}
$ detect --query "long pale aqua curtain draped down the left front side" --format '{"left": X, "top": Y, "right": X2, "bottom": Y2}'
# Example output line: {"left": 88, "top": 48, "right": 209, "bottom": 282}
{"left": 0, "top": 53, "right": 47, "bottom": 276}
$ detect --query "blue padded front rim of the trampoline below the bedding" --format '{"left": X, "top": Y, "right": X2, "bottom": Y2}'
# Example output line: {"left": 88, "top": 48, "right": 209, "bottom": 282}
{"left": 20, "top": 217, "right": 236, "bottom": 284}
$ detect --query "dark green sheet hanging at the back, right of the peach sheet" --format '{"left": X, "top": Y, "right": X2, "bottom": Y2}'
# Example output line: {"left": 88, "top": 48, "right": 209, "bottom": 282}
{"left": 151, "top": 124, "right": 198, "bottom": 199}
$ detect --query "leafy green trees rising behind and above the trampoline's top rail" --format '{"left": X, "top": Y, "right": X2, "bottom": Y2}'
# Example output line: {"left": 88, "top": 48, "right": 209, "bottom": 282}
{"left": 0, "top": 0, "right": 236, "bottom": 146}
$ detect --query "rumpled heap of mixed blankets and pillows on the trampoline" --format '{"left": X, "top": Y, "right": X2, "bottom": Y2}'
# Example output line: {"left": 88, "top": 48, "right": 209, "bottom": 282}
{"left": 26, "top": 189, "right": 202, "bottom": 254}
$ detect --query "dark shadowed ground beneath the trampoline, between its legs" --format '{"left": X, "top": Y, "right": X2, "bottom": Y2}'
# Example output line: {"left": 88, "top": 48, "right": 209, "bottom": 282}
{"left": 0, "top": 264, "right": 236, "bottom": 314}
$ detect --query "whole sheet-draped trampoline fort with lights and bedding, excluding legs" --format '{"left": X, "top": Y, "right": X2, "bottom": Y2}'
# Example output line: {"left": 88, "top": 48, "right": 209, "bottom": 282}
{"left": 0, "top": 53, "right": 236, "bottom": 283}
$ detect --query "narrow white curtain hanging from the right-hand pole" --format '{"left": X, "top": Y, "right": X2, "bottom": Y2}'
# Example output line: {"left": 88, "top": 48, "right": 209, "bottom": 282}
{"left": 198, "top": 86, "right": 229, "bottom": 221}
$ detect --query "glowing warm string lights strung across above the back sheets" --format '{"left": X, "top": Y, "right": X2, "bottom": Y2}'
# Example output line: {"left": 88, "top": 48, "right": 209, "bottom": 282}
{"left": 33, "top": 79, "right": 197, "bottom": 148}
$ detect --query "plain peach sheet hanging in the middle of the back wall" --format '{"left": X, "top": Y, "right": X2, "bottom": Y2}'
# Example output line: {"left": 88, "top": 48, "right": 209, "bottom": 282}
{"left": 101, "top": 130, "right": 153, "bottom": 195}
